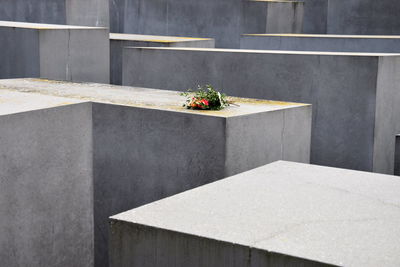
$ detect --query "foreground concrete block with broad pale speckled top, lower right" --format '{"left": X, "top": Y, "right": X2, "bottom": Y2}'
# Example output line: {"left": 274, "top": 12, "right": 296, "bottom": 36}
{"left": 110, "top": 161, "right": 400, "bottom": 267}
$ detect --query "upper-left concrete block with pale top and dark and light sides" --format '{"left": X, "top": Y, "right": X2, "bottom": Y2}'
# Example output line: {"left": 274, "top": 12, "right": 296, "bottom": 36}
{"left": 0, "top": 21, "right": 110, "bottom": 83}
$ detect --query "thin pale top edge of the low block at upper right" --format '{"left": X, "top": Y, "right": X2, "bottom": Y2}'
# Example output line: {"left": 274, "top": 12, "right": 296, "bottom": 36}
{"left": 242, "top": 33, "right": 400, "bottom": 39}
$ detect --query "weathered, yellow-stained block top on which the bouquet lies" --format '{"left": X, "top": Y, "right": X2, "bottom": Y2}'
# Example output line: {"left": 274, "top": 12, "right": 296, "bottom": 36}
{"left": 0, "top": 79, "right": 308, "bottom": 117}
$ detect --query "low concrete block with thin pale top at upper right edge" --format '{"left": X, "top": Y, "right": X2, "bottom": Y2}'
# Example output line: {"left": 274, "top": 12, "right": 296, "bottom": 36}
{"left": 240, "top": 34, "right": 400, "bottom": 53}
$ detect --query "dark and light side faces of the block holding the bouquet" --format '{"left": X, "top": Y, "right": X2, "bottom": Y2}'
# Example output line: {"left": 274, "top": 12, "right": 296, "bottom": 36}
{"left": 93, "top": 104, "right": 311, "bottom": 266}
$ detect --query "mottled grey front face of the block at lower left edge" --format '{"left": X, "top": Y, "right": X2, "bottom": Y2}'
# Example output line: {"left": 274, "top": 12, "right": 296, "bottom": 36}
{"left": 0, "top": 103, "right": 94, "bottom": 267}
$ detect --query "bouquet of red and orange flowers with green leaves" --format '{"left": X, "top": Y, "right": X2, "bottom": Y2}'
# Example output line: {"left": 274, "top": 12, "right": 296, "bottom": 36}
{"left": 181, "top": 85, "right": 229, "bottom": 110}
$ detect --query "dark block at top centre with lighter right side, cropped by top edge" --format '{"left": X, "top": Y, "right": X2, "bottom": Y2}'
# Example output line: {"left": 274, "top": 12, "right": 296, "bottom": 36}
{"left": 110, "top": 0, "right": 302, "bottom": 48}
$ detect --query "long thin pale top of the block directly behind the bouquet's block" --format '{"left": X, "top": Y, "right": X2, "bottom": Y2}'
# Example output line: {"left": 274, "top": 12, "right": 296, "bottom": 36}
{"left": 126, "top": 47, "right": 400, "bottom": 57}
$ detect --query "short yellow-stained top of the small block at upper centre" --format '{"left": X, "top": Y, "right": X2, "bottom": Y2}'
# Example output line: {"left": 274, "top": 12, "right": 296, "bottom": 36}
{"left": 110, "top": 33, "right": 213, "bottom": 43}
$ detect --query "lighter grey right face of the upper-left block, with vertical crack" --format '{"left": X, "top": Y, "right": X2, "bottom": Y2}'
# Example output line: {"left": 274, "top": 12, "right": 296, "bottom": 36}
{"left": 40, "top": 29, "right": 110, "bottom": 83}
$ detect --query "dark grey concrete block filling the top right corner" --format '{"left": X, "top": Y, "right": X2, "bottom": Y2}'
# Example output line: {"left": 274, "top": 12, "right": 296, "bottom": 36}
{"left": 304, "top": 0, "right": 400, "bottom": 35}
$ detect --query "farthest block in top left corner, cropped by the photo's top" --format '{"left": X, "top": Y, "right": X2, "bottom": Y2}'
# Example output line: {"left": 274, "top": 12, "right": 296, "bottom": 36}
{"left": 0, "top": 0, "right": 109, "bottom": 27}
